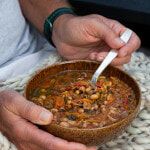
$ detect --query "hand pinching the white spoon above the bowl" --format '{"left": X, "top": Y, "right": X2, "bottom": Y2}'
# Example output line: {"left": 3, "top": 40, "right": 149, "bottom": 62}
{"left": 53, "top": 14, "right": 141, "bottom": 66}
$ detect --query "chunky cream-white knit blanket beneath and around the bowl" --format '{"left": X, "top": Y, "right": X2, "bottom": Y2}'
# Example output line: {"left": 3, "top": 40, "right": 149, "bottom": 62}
{"left": 0, "top": 52, "right": 150, "bottom": 150}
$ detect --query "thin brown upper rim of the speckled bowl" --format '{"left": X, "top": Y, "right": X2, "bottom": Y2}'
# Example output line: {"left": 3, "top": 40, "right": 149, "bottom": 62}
{"left": 23, "top": 60, "right": 141, "bottom": 131}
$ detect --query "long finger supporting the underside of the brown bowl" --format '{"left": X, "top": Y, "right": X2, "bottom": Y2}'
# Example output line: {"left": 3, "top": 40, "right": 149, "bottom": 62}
{"left": 10, "top": 106, "right": 95, "bottom": 150}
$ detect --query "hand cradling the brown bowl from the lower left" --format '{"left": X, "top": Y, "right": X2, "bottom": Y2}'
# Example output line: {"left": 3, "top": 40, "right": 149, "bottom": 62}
{"left": 0, "top": 91, "right": 96, "bottom": 150}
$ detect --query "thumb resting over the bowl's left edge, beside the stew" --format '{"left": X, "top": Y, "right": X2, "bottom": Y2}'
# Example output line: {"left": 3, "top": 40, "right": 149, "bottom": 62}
{"left": 1, "top": 91, "right": 53, "bottom": 125}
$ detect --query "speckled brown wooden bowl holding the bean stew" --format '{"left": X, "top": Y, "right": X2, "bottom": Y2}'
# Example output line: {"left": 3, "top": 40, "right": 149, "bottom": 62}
{"left": 25, "top": 60, "right": 141, "bottom": 145}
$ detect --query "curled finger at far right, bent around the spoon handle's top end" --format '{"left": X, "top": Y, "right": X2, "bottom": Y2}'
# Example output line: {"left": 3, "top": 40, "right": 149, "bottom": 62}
{"left": 118, "top": 33, "right": 141, "bottom": 57}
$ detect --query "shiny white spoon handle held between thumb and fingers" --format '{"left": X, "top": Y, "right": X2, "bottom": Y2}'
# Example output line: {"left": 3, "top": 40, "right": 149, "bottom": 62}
{"left": 91, "top": 29, "right": 132, "bottom": 84}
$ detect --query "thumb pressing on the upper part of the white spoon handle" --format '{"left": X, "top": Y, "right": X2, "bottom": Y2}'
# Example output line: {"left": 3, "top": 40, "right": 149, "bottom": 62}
{"left": 95, "top": 23, "right": 125, "bottom": 49}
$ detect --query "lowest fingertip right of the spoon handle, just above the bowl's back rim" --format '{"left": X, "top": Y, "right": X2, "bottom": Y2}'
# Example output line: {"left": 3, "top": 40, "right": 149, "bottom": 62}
{"left": 111, "top": 55, "right": 131, "bottom": 66}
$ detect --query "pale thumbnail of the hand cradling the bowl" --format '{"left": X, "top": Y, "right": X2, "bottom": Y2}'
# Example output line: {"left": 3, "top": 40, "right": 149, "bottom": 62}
{"left": 40, "top": 111, "right": 52, "bottom": 123}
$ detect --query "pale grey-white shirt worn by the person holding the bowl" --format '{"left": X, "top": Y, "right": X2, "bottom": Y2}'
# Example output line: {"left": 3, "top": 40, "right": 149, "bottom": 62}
{"left": 0, "top": 0, "right": 53, "bottom": 80}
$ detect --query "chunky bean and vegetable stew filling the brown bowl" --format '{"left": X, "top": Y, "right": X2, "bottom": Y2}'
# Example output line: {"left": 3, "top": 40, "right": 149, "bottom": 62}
{"left": 30, "top": 71, "right": 136, "bottom": 128}
